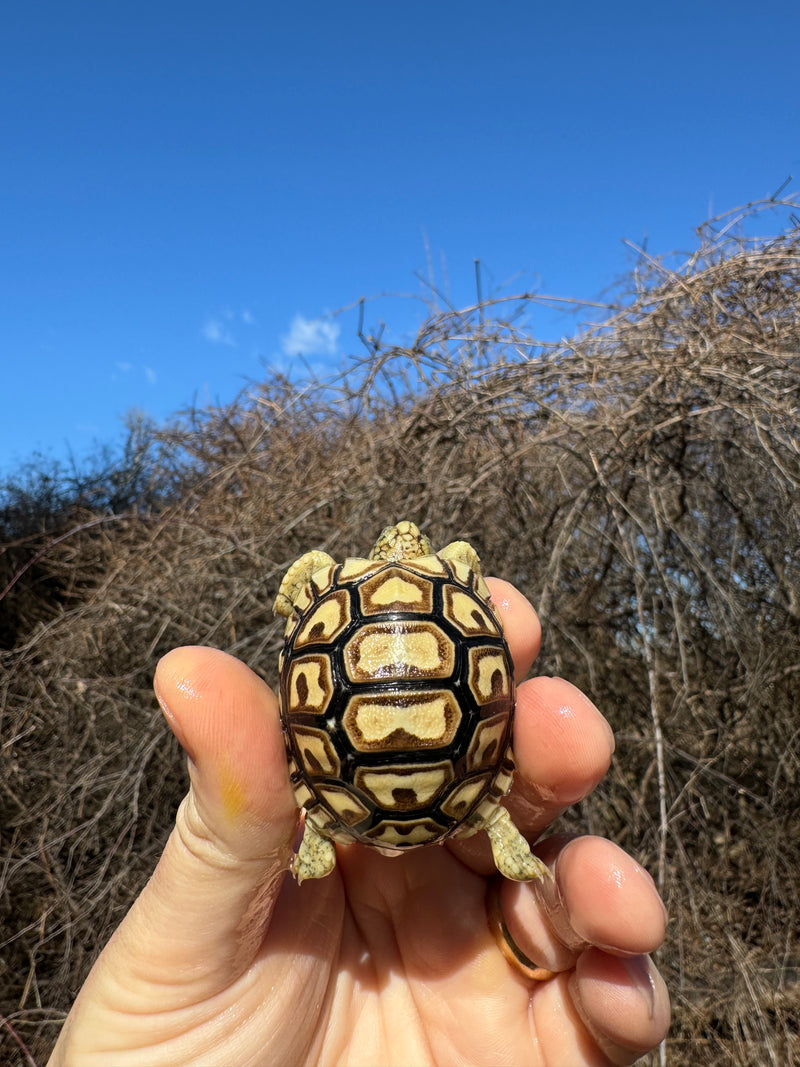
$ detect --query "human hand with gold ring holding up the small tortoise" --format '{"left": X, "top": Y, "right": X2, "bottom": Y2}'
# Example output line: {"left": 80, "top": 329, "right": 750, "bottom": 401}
{"left": 50, "top": 579, "right": 669, "bottom": 1067}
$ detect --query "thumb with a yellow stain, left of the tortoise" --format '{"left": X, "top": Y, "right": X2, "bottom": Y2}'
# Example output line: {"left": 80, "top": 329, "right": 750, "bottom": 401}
{"left": 110, "top": 648, "right": 298, "bottom": 1003}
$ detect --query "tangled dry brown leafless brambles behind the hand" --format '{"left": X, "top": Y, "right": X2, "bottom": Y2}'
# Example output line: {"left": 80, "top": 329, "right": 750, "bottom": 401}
{"left": 0, "top": 200, "right": 800, "bottom": 1067}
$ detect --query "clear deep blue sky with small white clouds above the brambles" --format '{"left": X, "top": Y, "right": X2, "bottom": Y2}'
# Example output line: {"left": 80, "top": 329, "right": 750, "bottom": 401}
{"left": 0, "top": 0, "right": 800, "bottom": 474}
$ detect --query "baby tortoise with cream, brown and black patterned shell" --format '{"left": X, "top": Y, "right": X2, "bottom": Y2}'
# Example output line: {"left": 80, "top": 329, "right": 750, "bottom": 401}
{"left": 275, "top": 522, "right": 547, "bottom": 882}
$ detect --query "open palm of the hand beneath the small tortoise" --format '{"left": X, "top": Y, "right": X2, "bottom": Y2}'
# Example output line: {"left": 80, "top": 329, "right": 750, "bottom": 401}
{"left": 115, "top": 846, "right": 627, "bottom": 1065}
